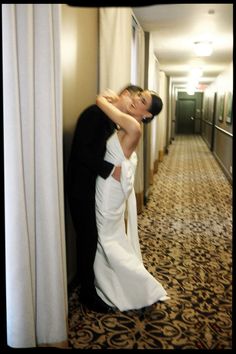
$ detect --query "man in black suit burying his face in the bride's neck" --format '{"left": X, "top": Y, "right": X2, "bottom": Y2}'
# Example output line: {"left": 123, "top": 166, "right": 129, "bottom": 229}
{"left": 67, "top": 85, "right": 143, "bottom": 313}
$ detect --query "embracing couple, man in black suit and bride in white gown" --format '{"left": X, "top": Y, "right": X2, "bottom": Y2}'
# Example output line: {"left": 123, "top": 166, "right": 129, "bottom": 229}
{"left": 67, "top": 85, "right": 168, "bottom": 313}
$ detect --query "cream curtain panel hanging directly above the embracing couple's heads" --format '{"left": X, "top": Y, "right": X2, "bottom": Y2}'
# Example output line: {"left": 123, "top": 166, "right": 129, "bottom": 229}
{"left": 99, "top": 7, "right": 132, "bottom": 92}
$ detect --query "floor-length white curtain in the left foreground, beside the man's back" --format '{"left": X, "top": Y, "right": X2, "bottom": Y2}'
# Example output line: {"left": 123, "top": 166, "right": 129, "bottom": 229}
{"left": 2, "top": 4, "right": 68, "bottom": 348}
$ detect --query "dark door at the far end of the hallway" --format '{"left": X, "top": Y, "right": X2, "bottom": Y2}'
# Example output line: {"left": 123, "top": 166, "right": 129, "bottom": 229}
{"left": 176, "top": 99, "right": 195, "bottom": 134}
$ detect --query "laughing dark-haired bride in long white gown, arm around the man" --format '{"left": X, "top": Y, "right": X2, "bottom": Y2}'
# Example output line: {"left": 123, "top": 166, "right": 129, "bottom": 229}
{"left": 94, "top": 90, "right": 168, "bottom": 311}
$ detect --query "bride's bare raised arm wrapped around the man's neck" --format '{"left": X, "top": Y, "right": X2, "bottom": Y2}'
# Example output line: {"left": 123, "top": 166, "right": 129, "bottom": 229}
{"left": 96, "top": 94, "right": 141, "bottom": 140}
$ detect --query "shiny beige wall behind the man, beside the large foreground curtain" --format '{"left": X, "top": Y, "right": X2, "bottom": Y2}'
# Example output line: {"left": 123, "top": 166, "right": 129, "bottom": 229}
{"left": 61, "top": 4, "right": 98, "bottom": 283}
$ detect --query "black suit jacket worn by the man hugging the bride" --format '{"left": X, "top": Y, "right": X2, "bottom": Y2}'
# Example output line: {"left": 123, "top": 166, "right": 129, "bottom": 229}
{"left": 67, "top": 105, "right": 115, "bottom": 201}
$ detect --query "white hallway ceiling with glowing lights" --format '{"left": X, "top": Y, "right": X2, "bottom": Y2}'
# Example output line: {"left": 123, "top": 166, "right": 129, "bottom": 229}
{"left": 132, "top": 4, "right": 233, "bottom": 89}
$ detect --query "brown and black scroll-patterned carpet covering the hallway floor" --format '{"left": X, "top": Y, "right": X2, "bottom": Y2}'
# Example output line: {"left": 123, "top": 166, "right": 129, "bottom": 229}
{"left": 69, "top": 136, "right": 232, "bottom": 349}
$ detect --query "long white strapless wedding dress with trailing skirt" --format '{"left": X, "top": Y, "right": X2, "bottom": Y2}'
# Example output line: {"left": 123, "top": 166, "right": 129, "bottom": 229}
{"left": 94, "top": 132, "right": 168, "bottom": 311}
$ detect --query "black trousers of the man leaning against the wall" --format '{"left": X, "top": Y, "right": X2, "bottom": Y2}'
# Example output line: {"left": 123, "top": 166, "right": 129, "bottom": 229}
{"left": 68, "top": 196, "right": 98, "bottom": 296}
